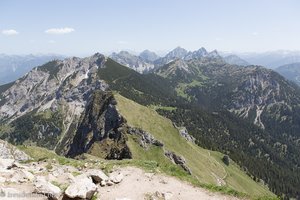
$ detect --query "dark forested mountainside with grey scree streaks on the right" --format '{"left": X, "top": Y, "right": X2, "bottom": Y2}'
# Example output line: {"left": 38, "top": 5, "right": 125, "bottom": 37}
{"left": 101, "top": 54, "right": 300, "bottom": 196}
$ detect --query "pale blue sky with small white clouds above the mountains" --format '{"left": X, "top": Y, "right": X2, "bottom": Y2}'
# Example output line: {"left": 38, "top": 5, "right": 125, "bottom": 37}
{"left": 0, "top": 0, "right": 300, "bottom": 56}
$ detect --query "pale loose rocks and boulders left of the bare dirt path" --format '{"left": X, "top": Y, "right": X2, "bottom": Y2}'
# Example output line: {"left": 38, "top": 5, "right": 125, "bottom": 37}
{"left": 0, "top": 139, "right": 123, "bottom": 200}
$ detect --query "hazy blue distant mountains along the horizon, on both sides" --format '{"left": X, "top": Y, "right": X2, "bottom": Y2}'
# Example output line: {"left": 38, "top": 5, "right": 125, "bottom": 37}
{"left": 0, "top": 47, "right": 300, "bottom": 85}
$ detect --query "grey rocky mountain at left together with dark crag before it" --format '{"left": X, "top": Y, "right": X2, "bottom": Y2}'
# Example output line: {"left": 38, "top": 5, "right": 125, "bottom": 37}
{"left": 0, "top": 53, "right": 130, "bottom": 158}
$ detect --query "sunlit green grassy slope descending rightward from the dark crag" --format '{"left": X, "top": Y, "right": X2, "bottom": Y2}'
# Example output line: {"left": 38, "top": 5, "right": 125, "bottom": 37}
{"left": 115, "top": 94, "right": 273, "bottom": 197}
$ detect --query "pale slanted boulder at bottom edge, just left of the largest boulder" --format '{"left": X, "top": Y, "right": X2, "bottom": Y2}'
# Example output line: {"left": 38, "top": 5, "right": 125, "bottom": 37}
{"left": 34, "top": 176, "right": 61, "bottom": 200}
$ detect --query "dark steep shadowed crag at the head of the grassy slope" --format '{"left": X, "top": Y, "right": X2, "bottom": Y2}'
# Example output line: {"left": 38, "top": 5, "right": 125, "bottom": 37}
{"left": 66, "top": 91, "right": 131, "bottom": 160}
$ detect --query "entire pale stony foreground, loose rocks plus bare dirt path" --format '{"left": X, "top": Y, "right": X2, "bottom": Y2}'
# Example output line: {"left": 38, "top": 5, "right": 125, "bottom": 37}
{"left": 0, "top": 141, "right": 236, "bottom": 200}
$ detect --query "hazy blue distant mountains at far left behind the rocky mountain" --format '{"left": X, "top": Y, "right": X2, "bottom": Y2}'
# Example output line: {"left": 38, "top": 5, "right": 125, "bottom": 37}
{"left": 0, "top": 54, "right": 64, "bottom": 85}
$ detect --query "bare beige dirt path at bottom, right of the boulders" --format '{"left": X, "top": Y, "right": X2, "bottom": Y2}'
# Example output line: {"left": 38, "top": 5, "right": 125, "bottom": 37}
{"left": 98, "top": 167, "right": 238, "bottom": 200}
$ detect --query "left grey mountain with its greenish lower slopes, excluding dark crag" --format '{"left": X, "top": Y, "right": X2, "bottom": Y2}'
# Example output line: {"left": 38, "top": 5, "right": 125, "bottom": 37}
{"left": 0, "top": 54, "right": 108, "bottom": 154}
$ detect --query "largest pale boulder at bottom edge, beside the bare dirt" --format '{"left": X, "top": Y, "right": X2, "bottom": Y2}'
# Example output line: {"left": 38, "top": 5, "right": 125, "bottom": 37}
{"left": 65, "top": 174, "right": 97, "bottom": 199}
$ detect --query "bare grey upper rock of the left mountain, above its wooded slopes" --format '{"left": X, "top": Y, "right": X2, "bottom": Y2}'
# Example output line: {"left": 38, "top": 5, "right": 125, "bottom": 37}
{"left": 0, "top": 54, "right": 106, "bottom": 120}
